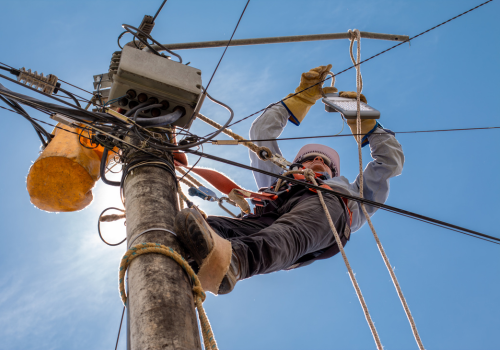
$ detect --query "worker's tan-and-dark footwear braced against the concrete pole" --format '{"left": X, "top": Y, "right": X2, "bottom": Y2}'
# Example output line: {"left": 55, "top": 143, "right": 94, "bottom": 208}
{"left": 174, "top": 208, "right": 241, "bottom": 295}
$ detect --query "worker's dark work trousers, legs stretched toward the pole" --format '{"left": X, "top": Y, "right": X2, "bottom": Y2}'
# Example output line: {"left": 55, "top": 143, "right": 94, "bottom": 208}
{"left": 207, "top": 192, "right": 346, "bottom": 278}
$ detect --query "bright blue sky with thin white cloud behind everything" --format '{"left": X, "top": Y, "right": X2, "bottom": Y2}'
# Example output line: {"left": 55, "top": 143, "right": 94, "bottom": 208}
{"left": 0, "top": 0, "right": 500, "bottom": 350}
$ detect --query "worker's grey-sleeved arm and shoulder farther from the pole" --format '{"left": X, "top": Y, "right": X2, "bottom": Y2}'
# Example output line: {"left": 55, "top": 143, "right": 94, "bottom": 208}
{"left": 326, "top": 127, "right": 404, "bottom": 232}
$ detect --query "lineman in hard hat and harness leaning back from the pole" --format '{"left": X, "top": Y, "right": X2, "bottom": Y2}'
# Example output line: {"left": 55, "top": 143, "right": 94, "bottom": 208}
{"left": 175, "top": 65, "right": 404, "bottom": 294}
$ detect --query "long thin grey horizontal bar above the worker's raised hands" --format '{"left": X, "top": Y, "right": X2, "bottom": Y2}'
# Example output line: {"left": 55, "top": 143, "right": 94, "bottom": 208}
{"left": 153, "top": 32, "right": 410, "bottom": 51}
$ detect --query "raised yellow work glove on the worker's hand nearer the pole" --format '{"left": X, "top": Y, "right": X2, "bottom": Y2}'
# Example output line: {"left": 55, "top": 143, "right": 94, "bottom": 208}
{"left": 283, "top": 64, "right": 337, "bottom": 125}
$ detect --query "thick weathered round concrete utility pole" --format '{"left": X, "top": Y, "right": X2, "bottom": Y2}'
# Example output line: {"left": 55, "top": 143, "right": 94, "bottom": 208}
{"left": 124, "top": 151, "right": 201, "bottom": 350}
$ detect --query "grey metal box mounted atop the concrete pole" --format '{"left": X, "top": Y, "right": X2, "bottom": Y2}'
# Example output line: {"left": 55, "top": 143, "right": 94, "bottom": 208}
{"left": 109, "top": 46, "right": 202, "bottom": 127}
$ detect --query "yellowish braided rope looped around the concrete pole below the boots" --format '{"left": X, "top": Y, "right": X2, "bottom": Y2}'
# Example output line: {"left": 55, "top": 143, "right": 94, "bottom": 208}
{"left": 118, "top": 243, "right": 218, "bottom": 350}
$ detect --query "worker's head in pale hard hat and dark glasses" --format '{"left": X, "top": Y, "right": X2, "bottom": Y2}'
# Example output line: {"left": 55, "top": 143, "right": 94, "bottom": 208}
{"left": 293, "top": 144, "right": 340, "bottom": 177}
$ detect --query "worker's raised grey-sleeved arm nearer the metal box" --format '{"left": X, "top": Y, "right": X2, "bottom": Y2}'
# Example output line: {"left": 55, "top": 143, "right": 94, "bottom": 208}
{"left": 249, "top": 104, "right": 289, "bottom": 188}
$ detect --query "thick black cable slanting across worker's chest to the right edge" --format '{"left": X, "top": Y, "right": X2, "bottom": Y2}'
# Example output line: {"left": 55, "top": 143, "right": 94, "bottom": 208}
{"left": 186, "top": 150, "right": 500, "bottom": 245}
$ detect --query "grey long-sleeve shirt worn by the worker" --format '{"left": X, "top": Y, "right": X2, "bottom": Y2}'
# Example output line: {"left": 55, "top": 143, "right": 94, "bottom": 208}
{"left": 249, "top": 105, "right": 404, "bottom": 232}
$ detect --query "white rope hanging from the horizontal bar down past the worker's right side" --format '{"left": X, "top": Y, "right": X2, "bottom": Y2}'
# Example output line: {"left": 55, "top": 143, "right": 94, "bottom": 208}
{"left": 349, "top": 29, "right": 425, "bottom": 350}
